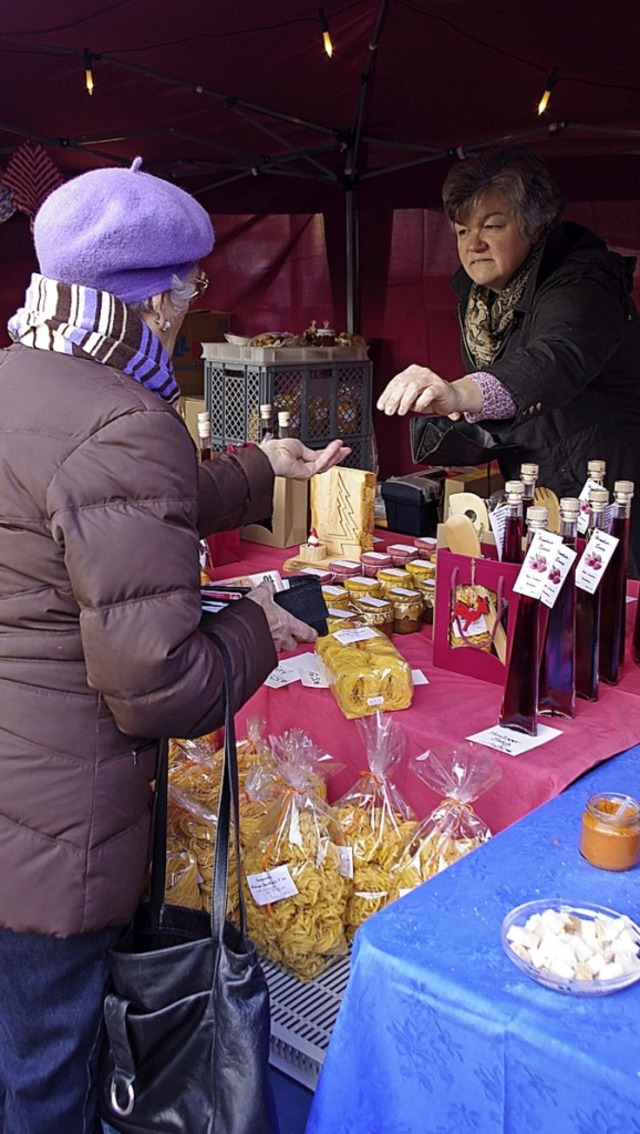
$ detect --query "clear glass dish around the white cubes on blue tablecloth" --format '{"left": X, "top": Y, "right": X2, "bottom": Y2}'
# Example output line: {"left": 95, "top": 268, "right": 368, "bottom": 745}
{"left": 500, "top": 898, "right": 640, "bottom": 996}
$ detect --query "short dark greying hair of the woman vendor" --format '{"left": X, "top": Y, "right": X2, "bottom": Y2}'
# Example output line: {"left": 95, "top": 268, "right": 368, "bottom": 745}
{"left": 443, "top": 145, "right": 564, "bottom": 236}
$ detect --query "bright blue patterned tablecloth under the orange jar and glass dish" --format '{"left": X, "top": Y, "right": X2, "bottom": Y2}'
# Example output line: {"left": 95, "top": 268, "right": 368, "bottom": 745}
{"left": 306, "top": 745, "right": 640, "bottom": 1134}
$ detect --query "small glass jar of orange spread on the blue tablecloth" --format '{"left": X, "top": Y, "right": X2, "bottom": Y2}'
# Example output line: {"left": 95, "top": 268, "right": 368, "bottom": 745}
{"left": 580, "top": 792, "right": 640, "bottom": 870}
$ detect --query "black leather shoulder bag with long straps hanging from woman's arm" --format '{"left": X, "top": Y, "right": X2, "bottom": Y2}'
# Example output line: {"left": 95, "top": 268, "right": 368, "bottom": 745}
{"left": 100, "top": 627, "right": 278, "bottom": 1134}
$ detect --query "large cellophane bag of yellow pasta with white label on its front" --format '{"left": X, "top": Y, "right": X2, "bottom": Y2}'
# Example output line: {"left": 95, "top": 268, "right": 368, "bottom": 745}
{"left": 243, "top": 729, "right": 348, "bottom": 980}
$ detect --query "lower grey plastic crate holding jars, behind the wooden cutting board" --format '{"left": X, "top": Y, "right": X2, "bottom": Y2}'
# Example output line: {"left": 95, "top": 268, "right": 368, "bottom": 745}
{"left": 204, "top": 360, "right": 373, "bottom": 469}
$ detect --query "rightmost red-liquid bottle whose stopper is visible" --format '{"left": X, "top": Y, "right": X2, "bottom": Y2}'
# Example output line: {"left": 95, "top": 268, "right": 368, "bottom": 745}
{"left": 598, "top": 481, "right": 633, "bottom": 685}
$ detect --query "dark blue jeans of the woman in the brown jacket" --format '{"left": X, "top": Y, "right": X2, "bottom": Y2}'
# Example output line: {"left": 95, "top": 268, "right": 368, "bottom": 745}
{"left": 0, "top": 929, "right": 121, "bottom": 1134}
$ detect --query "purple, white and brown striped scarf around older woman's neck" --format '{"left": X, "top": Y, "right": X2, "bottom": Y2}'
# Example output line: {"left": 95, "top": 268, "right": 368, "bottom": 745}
{"left": 9, "top": 272, "right": 180, "bottom": 404}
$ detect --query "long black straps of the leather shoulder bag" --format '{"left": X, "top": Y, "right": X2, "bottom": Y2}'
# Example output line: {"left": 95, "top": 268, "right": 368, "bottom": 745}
{"left": 150, "top": 623, "right": 246, "bottom": 941}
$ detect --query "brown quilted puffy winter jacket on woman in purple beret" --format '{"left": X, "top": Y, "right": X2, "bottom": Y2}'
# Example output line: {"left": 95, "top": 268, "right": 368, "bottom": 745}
{"left": 0, "top": 346, "right": 276, "bottom": 937}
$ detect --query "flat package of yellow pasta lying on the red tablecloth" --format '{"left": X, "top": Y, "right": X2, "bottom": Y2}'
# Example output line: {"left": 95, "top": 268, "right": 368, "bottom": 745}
{"left": 315, "top": 626, "right": 413, "bottom": 720}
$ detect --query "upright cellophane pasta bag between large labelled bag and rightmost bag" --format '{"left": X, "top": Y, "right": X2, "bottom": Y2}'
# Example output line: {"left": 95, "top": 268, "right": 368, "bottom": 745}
{"left": 335, "top": 713, "right": 416, "bottom": 939}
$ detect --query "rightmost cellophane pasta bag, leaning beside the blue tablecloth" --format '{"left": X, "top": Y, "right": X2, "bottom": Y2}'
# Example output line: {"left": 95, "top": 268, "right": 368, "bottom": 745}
{"left": 394, "top": 742, "right": 502, "bottom": 896}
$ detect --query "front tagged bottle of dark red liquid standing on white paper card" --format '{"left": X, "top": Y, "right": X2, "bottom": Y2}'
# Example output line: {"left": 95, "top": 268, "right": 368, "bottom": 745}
{"left": 498, "top": 507, "right": 547, "bottom": 736}
